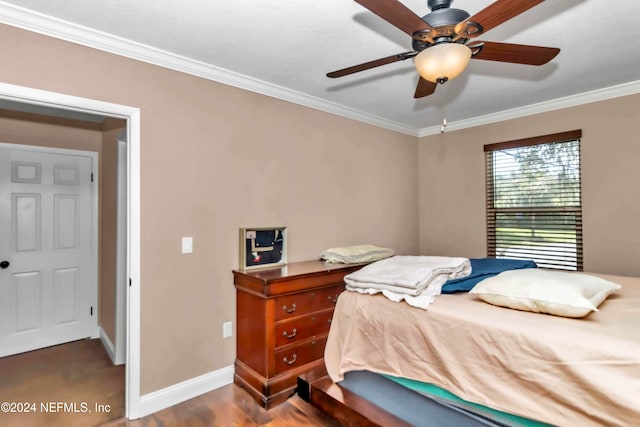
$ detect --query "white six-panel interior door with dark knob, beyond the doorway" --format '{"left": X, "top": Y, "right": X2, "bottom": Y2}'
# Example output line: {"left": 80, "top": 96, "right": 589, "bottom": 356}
{"left": 0, "top": 144, "right": 98, "bottom": 357}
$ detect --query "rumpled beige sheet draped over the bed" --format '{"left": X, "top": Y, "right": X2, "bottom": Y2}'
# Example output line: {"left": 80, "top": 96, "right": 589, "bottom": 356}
{"left": 325, "top": 275, "right": 640, "bottom": 427}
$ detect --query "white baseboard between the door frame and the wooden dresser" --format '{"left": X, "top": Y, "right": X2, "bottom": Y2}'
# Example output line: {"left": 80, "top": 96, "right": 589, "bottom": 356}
{"left": 139, "top": 365, "right": 234, "bottom": 417}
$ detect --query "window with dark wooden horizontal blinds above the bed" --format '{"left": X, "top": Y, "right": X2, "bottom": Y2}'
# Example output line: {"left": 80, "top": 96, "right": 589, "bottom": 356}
{"left": 484, "top": 130, "right": 582, "bottom": 271}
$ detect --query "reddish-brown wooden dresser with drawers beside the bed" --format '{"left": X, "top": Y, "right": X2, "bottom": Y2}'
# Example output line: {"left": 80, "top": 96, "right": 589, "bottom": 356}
{"left": 233, "top": 261, "right": 362, "bottom": 408}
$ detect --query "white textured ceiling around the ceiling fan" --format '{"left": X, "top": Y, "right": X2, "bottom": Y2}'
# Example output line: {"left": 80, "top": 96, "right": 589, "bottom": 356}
{"left": 0, "top": 0, "right": 640, "bottom": 134}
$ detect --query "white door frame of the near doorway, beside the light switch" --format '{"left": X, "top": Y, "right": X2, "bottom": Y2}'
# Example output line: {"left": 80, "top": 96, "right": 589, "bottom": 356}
{"left": 0, "top": 82, "right": 141, "bottom": 419}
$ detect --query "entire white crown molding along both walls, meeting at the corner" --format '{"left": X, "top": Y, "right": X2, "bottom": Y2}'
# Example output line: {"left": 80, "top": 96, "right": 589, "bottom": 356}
{"left": 0, "top": 1, "right": 640, "bottom": 137}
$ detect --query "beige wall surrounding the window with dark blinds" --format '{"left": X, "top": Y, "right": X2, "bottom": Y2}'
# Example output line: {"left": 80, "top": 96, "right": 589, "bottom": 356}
{"left": 419, "top": 95, "right": 640, "bottom": 276}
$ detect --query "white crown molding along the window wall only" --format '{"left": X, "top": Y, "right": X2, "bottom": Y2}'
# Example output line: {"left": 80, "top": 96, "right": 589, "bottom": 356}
{"left": 418, "top": 80, "right": 640, "bottom": 137}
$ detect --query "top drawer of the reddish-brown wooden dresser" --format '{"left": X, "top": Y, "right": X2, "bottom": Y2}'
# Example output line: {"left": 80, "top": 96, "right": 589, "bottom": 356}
{"left": 274, "top": 285, "right": 344, "bottom": 320}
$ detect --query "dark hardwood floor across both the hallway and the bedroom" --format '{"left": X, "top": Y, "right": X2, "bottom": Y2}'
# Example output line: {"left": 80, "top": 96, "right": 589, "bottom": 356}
{"left": 0, "top": 340, "right": 340, "bottom": 427}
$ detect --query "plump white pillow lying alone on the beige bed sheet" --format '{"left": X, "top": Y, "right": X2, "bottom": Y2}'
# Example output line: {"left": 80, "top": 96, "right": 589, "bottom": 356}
{"left": 470, "top": 268, "right": 622, "bottom": 317}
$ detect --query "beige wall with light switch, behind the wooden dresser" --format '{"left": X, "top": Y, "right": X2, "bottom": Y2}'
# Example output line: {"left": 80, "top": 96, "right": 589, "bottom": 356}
{"left": 0, "top": 26, "right": 418, "bottom": 394}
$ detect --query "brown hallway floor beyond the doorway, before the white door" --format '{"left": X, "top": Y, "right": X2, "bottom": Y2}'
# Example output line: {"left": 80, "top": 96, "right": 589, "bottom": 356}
{"left": 0, "top": 339, "right": 125, "bottom": 427}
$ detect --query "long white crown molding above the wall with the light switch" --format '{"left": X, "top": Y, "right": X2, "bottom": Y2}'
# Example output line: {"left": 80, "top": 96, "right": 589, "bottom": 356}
{"left": 0, "top": 1, "right": 418, "bottom": 136}
